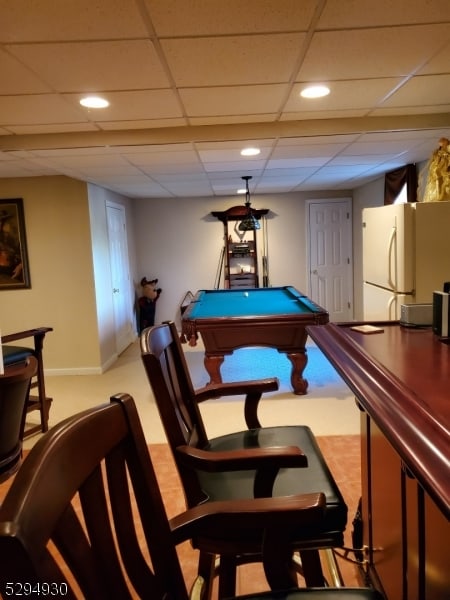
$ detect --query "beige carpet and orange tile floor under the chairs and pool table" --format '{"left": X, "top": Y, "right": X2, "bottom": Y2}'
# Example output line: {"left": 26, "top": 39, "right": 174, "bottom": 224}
{"left": 7, "top": 342, "right": 361, "bottom": 593}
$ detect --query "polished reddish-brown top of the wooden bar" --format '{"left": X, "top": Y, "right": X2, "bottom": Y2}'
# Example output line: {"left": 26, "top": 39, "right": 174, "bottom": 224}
{"left": 308, "top": 322, "right": 450, "bottom": 519}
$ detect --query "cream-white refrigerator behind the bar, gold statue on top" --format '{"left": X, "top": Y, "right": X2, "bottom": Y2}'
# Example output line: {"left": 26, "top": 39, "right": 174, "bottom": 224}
{"left": 362, "top": 202, "right": 450, "bottom": 321}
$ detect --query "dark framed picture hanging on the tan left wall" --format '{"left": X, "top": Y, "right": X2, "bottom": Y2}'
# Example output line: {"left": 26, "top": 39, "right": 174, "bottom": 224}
{"left": 0, "top": 198, "right": 31, "bottom": 290}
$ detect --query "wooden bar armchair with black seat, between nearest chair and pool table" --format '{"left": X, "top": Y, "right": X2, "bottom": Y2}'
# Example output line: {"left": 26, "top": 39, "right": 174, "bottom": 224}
{"left": 140, "top": 323, "right": 347, "bottom": 597}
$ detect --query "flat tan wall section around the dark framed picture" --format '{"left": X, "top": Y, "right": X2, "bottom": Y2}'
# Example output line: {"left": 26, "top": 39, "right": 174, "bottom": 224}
{"left": 0, "top": 176, "right": 99, "bottom": 370}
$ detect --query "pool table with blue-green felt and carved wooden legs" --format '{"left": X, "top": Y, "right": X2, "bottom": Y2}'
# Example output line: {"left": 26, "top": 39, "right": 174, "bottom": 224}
{"left": 181, "top": 286, "right": 328, "bottom": 394}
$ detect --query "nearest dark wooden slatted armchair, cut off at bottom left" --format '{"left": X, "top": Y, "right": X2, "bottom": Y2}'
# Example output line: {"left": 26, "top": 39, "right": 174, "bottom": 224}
{"left": 0, "top": 394, "right": 379, "bottom": 600}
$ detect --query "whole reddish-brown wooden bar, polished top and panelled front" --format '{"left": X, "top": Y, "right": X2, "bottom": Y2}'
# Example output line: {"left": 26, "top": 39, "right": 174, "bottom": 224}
{"left": 308, "top": 322, "right": 450, "bottom": 600}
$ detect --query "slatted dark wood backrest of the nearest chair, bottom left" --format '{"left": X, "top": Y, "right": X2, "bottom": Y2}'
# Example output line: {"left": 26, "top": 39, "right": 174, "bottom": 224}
{"left": 0, "top": 396, "right": 187, "bottom": 600}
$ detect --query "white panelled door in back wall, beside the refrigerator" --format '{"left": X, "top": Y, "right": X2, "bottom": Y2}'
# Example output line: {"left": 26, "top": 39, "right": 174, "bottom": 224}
{"left": 307, "top": 198, "right": 353, "bottom": 322}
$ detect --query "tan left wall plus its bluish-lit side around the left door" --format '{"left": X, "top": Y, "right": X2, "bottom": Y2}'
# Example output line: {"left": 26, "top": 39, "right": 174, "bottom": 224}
{"left": 0, "top": 176, "right": 135, "bottom": 375}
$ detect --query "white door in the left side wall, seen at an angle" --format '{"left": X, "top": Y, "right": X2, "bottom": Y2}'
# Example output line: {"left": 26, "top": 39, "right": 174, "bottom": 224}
{"left": 106, "top": 203, "right": 133, "bottom": 354}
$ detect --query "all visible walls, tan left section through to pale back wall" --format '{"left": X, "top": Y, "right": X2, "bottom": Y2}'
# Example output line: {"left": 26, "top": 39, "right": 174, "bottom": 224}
{"left": 0, "top": 170, "right": 383, "bottom": 374}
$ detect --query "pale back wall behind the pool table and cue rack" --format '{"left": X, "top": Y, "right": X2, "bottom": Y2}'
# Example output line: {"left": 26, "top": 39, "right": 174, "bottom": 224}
{"left": 133, "top": 191, "right": 351, "bottom": 323}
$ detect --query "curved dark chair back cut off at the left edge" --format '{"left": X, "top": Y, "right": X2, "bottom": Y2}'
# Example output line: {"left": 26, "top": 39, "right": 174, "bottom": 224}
{"left": 0, "top": 356, "right": 37, "bottom": 481}
